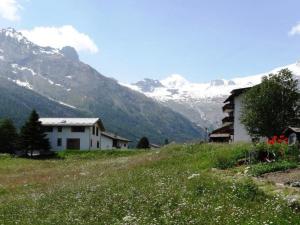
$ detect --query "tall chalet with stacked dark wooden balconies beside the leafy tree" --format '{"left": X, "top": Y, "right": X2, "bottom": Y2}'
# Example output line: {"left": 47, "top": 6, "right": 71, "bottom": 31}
{"left": 209, "top": 88, "right": 252, "bottom": 142}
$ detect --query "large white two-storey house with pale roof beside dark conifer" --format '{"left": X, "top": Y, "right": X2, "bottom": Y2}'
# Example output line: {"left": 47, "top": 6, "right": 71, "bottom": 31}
{"left": 40, "top": 118, "right": 129, "bottom": 151}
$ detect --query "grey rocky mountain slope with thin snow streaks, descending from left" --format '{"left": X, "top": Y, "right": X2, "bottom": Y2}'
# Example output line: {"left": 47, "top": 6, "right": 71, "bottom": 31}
{"left": 0, "top": 28, "right": 204, "bottom": 143}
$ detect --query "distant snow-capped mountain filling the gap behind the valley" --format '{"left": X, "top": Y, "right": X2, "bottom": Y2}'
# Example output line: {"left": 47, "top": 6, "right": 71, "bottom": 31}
{"left": 124, "top": 62, "right": 300, "bottom": 128}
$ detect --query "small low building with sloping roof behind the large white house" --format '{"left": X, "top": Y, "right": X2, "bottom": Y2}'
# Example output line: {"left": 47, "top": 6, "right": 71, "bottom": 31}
{"left": 101, "top": 131, "right": 131, "bottom": 149}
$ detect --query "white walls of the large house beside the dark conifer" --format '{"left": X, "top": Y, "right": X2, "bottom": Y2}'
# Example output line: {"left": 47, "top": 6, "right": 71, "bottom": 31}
{"left": 46, "top": 125, "right": 101, "bottom": 151}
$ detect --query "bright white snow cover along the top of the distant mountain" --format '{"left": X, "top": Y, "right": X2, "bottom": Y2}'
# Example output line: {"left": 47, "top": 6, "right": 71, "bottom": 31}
{"left": 125, "top": 62, "right": 300, "bottom": 101}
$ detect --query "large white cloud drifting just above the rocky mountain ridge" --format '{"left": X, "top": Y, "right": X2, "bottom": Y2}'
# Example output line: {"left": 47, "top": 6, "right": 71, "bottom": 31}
{"left": 20, "top": 25, "right": 98, "bottom": 53}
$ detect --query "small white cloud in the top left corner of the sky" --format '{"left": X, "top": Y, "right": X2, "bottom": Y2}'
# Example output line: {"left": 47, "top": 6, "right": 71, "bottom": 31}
{"left": 0, "top": 0, "right": 22, "bottom": 21}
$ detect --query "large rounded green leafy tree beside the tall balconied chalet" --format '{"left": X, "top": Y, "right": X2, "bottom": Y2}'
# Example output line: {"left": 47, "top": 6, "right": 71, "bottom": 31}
{"left": 241, "top": 69, "right": 300, "bottom": 138}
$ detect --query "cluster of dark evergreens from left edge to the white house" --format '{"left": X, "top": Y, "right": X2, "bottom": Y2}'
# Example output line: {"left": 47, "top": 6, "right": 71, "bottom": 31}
{"left": 0, "top": 110, "right": 50, "bottom": 156}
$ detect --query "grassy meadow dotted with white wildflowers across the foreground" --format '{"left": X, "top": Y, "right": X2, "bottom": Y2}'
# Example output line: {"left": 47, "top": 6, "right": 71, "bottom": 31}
{"left": 0, "top": 144, "right": 300, "bottom": 225}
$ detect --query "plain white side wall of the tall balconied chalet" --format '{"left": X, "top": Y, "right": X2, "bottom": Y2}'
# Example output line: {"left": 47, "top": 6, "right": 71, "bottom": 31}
{"left": 233, "top": 95, "right": 251, "bottom": 142}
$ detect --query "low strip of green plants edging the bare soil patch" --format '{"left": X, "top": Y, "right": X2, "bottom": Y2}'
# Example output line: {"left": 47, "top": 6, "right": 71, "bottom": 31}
{"left": 249, "top": 161, "right": 298, "bottom": 176}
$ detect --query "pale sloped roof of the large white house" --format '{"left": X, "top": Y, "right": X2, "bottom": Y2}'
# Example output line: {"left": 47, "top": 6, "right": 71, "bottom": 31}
{"left": 39, "top": 118, "right": 104, "bottom": 130}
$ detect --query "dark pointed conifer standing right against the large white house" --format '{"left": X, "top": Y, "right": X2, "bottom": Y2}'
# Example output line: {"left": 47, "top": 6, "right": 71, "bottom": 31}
{"left": 20, "top": 110, "right": 50, "bottom": 156}
